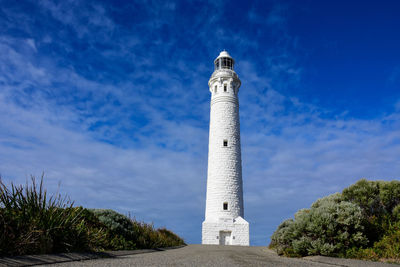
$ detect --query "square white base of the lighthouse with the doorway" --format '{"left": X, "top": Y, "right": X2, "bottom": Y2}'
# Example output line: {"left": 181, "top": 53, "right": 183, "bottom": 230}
{"left": 201, "top": 216, "right": 250, "bottom": 246}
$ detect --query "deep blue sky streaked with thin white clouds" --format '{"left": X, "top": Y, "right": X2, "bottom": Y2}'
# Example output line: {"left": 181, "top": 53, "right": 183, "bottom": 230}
{"left": 0, "top": 0, "right": 400, "bottom": 246}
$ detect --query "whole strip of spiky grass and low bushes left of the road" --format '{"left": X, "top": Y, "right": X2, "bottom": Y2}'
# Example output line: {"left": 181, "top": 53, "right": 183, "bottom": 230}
{"left": 0, "top": 177, "right": 184, "bottom": 256}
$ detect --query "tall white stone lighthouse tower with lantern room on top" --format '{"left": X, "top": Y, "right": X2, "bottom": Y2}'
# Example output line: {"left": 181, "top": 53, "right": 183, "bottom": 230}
{"left": 202, "top": 51, "right": 249, "bottom": 246}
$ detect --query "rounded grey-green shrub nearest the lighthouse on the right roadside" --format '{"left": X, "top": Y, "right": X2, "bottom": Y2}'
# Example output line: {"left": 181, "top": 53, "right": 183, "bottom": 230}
{"left": 271, "top": 194, "right": 367, "bottom": 256}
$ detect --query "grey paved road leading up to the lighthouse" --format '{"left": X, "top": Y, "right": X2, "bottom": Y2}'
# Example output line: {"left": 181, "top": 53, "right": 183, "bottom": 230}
{"left": 44, "top": 245, "right": 396, "bottom": 267}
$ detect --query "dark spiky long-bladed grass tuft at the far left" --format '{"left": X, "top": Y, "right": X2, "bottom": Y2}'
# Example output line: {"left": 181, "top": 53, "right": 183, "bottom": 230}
{"left": 0, "top": 177, "right": 86, "bottom": 255}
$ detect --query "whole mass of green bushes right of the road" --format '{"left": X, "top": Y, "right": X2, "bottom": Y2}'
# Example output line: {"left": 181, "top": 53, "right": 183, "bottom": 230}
{"left": 269, "top": 179, "right": 400, "bottom": 263}
